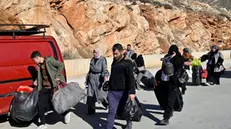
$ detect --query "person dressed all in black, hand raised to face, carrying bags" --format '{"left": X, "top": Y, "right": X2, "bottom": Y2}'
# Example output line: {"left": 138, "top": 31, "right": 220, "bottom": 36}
{"left": 160, "top": 45, "right": 184, "bottom": 125}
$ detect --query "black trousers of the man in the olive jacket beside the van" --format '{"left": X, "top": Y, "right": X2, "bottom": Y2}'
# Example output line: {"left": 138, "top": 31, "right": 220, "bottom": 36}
{"left": 38, "top": 88, "right": 53, "bottom": 124}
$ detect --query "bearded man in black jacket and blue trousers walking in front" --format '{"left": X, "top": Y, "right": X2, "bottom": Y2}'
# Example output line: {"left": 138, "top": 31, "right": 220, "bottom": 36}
{"left": 107, "top": 44, "right": 135, "bottom": 129}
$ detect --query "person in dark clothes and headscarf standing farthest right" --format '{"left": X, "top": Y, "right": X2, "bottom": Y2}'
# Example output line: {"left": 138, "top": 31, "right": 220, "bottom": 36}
{"left": 200, "top": 45, "right": 225, "bottom": 85}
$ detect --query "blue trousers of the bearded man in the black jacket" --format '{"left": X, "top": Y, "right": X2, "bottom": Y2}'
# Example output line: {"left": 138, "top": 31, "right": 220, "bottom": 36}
{"left": 107, "top": 91, "right": 123, "bottom": 129}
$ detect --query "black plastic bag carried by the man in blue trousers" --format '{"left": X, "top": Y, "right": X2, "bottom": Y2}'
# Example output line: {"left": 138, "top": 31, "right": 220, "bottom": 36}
{"left": 120, "top": 98, "right": 143, "bottom": 122}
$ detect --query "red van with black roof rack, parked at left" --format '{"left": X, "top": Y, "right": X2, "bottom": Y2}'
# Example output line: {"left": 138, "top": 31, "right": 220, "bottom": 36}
{"left": 0, "top": 24, "right": 66, "bottom": 115}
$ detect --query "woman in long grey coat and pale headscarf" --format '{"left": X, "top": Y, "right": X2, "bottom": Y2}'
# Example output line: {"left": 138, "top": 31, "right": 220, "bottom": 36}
{"left": 86, "top": 48, "right": 109, "bottom": 115}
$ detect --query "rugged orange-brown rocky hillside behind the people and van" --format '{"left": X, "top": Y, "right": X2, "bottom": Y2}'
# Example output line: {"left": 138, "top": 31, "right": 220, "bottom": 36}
{"left": 0, "top": 0, "right": 231, "bottom": 59}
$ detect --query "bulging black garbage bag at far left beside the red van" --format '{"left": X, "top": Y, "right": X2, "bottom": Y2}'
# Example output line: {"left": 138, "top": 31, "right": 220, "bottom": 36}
{"left": 11, "top": 90, "right": 38, "bottom": 121}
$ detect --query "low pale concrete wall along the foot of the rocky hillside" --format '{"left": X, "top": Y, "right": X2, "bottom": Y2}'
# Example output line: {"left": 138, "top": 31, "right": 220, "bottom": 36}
{"left": 64, "top": 50, "right": 231, "bottom": 76}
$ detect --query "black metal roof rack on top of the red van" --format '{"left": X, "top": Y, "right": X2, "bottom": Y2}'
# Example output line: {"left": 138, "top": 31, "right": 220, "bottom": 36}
{"left": 0, "top": 24, "right": 49, "bottom": 38}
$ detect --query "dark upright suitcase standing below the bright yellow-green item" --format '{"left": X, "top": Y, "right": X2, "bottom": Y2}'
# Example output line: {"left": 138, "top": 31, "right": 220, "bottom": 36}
{"left": 192, "top": 67, "right": 201, "bottom": 85}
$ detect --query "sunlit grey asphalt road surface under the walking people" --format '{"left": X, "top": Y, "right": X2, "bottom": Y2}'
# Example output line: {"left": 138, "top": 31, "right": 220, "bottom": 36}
{"left": 0, "top": 60, "right": 231, "bottom": 129}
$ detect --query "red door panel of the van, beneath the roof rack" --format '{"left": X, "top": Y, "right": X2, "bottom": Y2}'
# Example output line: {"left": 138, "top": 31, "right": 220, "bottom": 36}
{"left": 0, "top": 40, "right": 58, "bottom": 114}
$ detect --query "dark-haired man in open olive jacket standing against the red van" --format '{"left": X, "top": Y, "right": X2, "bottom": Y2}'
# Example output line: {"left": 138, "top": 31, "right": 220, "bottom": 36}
{"left": 31, "top": 51, "right": 70, "bottom": 129}
